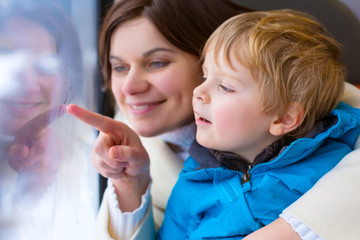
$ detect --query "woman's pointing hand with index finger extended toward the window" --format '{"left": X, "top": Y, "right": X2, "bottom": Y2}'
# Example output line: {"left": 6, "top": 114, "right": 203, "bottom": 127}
{"left": 67, "top": 104, "right": 150, "bottom": 212}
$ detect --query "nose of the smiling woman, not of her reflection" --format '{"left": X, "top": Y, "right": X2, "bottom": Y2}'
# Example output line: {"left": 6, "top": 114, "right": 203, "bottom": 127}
{"left": 122, "top": 69, "right": 150, "bottom": 95}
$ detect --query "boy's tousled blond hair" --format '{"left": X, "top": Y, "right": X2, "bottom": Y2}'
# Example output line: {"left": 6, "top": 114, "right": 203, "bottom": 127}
{"left": 203, "top": 9, "right": 345, "bottom": 137}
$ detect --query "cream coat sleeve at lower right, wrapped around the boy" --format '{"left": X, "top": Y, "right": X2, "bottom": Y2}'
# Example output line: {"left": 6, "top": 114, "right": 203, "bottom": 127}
{"left": 284, "top": 149, "right": 360, "bottom": 240}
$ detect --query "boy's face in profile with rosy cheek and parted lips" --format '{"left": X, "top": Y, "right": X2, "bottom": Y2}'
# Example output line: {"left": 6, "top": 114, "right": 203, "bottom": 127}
{"left": 193, "top": 51, "right": 277, "bottom": 162}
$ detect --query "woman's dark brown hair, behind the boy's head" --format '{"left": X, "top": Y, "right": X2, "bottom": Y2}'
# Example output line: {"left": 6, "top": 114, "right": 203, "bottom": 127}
{"left": 99, "top": 0, "right": 250, "bottom": 86}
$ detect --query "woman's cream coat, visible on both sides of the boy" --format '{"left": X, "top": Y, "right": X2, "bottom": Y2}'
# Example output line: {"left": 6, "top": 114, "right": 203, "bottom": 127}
{"left": 95, "top": 84, "right": 360, "bottom": 240}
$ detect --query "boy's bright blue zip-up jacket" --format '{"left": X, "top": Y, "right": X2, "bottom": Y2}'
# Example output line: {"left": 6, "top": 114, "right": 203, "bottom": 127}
{"left": 157, "top": 103, "right": 360, "bottom": 240}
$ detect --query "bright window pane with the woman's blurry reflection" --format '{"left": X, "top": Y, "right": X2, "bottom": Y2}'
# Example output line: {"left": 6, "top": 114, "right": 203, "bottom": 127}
{"left": 0, "top": 0, "right": 97, "bottom": 240}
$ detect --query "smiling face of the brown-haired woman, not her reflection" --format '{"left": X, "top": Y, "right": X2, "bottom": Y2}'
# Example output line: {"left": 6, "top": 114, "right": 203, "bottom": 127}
{"left": 109, "top": 17, "right": 202, "bottom": 137}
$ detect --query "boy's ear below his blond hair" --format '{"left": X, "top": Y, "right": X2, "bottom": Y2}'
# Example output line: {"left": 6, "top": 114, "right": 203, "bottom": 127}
{"left": 270, "top": 102, "right": 305, "bottom": 136}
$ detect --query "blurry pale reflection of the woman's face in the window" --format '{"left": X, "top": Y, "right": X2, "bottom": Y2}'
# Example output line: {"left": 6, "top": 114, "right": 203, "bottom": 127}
{"left": 0, "top": 19, "right": 63, "bottom": 135}
